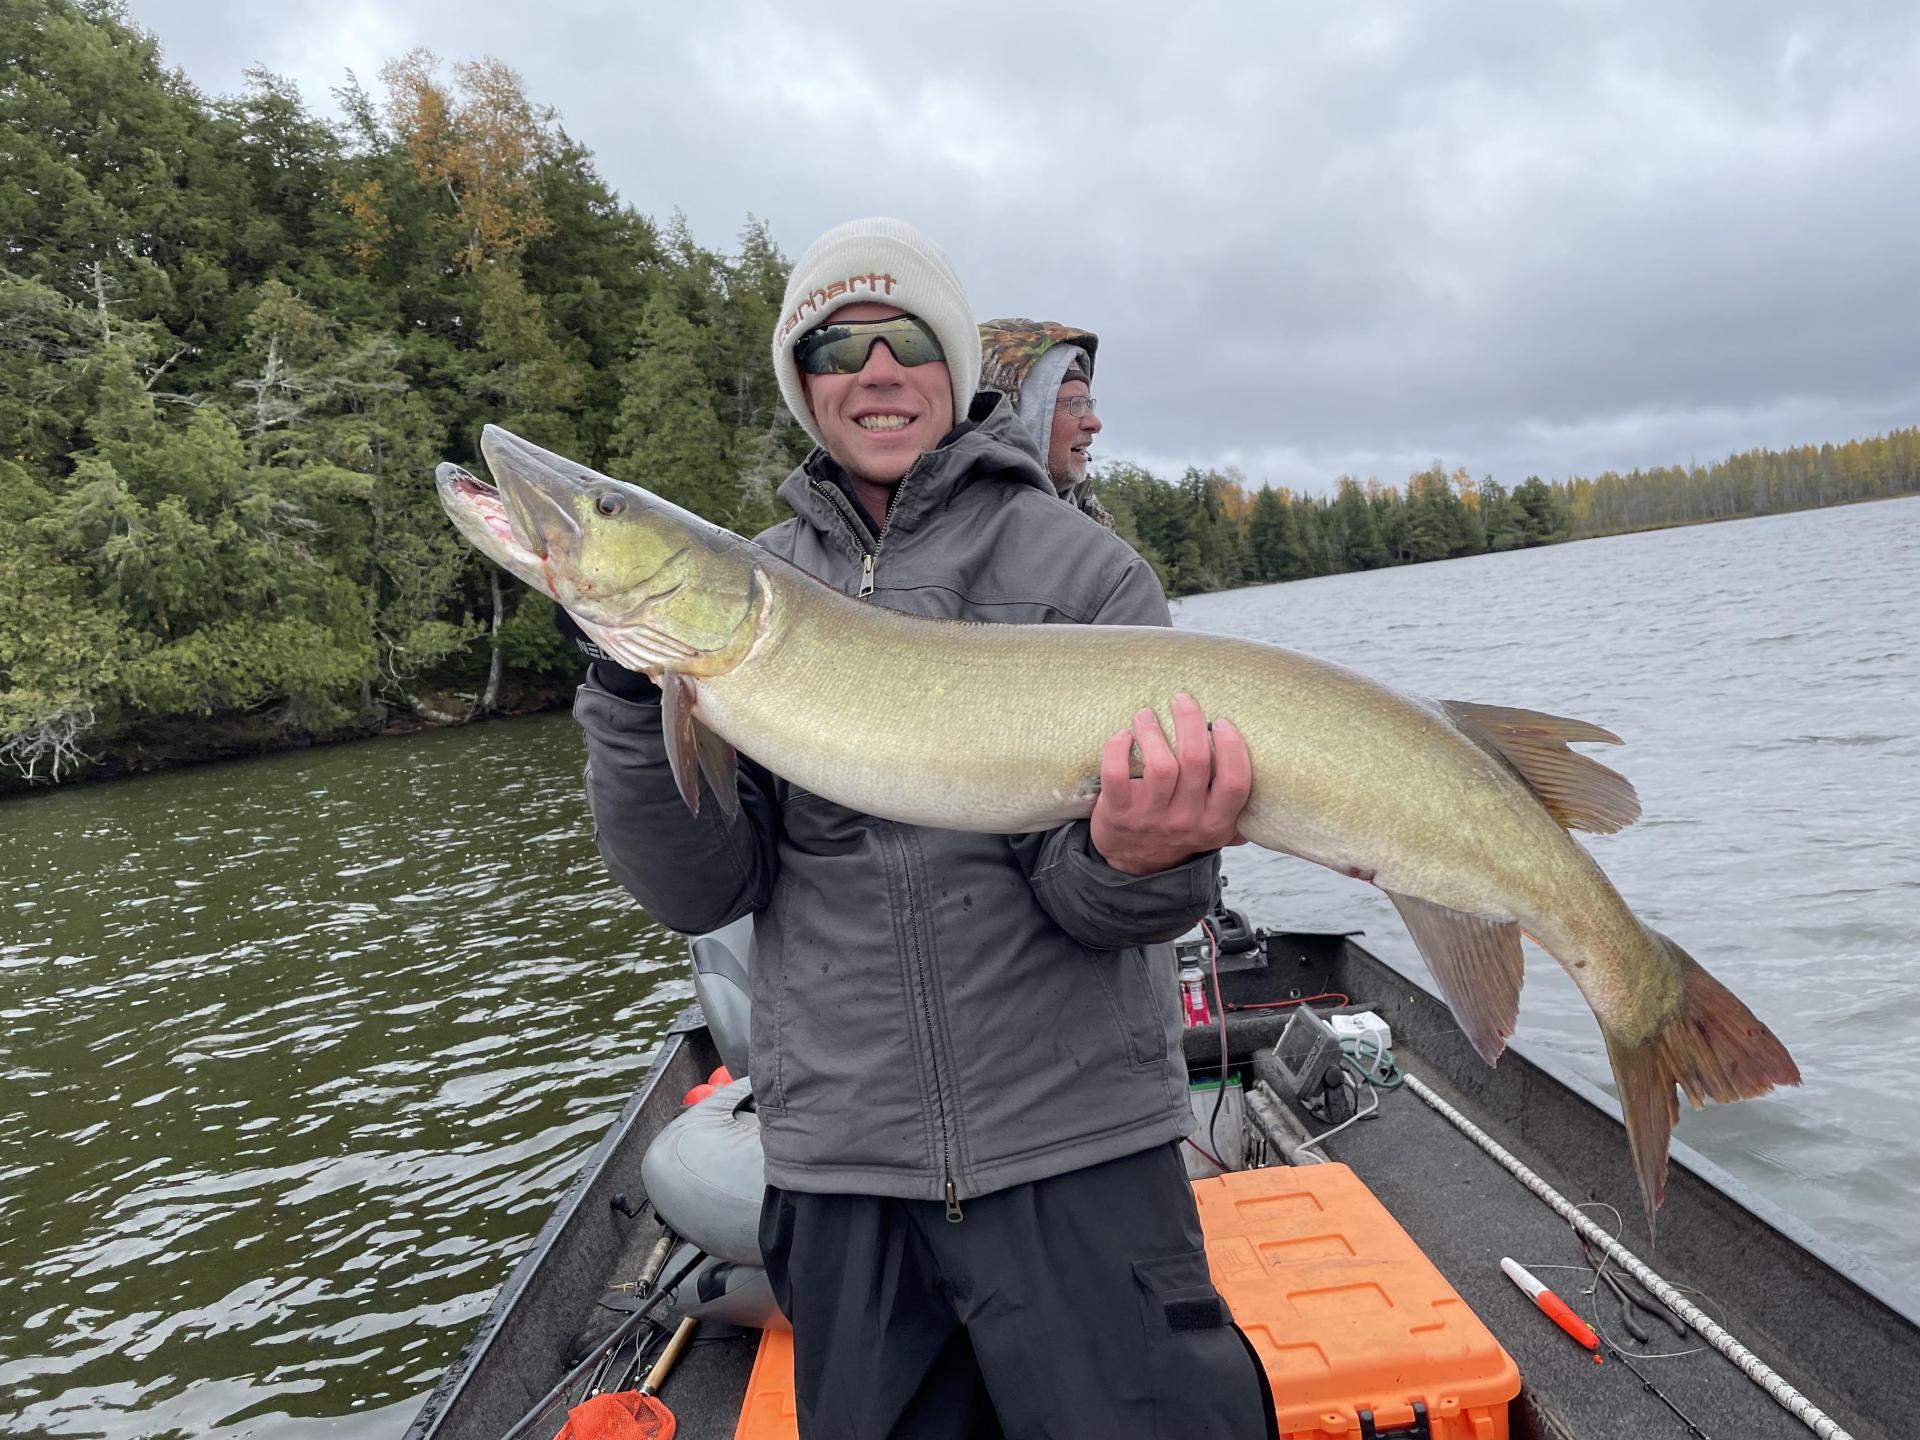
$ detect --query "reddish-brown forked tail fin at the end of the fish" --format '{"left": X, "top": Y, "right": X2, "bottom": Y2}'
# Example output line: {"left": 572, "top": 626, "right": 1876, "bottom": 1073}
{"left": 1601, "top": 929, "right": 1801, "bottom": 1233}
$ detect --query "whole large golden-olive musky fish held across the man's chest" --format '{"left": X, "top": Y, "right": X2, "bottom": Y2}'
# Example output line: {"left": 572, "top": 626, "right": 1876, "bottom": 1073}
{"left": 440, "top": 426, "right": 1799, "bottom": 1223}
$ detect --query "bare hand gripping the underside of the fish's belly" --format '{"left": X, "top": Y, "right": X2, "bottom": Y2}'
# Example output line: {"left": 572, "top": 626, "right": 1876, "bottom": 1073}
{"left": 1092, "top": 691, "right": 1254, "bottom": 876}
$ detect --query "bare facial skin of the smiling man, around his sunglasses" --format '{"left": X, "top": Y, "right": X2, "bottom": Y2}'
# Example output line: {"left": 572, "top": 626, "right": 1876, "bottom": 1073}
{"left": 801, "top": 301, "right": 954, "bottom": 509}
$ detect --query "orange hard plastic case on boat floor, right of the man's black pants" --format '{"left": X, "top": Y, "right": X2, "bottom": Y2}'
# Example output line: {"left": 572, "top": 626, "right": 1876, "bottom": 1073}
{"left": 1194, "top": 1164, "right": 1521, "bottom": 1440}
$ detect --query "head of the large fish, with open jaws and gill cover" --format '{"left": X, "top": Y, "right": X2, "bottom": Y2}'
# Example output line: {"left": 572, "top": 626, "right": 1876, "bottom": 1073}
{"left": 436, "top": 424, "right": 770, "bottom": 676}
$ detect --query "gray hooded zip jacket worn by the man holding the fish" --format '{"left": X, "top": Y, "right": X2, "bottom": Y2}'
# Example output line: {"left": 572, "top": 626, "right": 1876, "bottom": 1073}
{"left": 574, "top": 394, "right": 1219, "bottom": 1208}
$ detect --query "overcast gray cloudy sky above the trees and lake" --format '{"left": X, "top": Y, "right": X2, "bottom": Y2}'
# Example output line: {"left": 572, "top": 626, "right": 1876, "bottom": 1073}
{"left": 132, "top": 0, "right": 1920, "bottom": 490}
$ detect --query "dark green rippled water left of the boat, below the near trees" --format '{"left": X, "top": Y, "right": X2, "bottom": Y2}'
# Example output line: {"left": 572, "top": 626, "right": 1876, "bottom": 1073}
{"left": 0, "top": 716, "right": 680, "bottom": 1436}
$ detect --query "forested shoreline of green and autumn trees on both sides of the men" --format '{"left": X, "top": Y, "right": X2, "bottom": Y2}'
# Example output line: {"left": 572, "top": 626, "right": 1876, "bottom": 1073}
{"left": 0, "top": 0, "right": 1920, "bottom": 787}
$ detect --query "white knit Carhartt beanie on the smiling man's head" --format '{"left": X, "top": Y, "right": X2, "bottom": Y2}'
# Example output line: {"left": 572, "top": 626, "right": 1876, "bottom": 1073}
{"left": 774, "top": 217, "right": 979, "bottom": 445}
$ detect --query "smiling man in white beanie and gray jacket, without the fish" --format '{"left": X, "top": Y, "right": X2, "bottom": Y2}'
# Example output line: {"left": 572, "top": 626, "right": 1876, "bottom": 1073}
{"left": 560, "top": 219, "right": 1267, "bottom": 1440}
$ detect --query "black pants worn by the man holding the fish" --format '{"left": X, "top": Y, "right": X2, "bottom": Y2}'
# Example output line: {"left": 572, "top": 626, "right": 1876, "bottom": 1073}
{"left": 760, "top": 1146, "right": 1275, "bottom": 1440}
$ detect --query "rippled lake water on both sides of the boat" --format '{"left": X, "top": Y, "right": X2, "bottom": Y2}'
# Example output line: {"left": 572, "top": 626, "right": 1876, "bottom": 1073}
{"left": 0, "top": 499, "right": 1920, "bottom": 1440}
